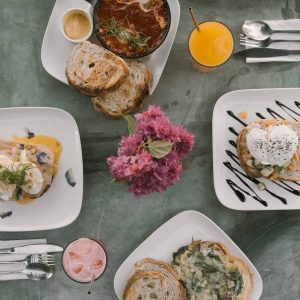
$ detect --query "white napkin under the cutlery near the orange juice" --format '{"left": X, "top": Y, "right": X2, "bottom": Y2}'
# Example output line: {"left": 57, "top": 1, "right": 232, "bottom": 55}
{"left": 245, "top": 19, "right": 300, "bottom": 63}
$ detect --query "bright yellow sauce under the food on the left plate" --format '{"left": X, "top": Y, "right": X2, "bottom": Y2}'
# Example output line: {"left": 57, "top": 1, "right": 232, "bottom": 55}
{"left": 13, "top": 135, "right": 62, "bottom": 204}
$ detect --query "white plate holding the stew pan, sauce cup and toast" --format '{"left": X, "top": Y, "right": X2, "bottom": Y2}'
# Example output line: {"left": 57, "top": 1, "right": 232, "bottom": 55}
{"left": 41, "top": 0, "right": 180, "bottom": 94}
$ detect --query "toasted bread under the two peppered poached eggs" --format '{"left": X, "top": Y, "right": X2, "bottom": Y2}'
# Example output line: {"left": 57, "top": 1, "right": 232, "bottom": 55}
{"left": 236, "top": 120, "right": 300, "bottom": 181}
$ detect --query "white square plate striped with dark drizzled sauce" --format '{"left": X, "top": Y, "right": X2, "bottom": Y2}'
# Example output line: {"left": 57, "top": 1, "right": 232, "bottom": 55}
{"left": 213, "top": 89, "right": 300, "bottom": 210}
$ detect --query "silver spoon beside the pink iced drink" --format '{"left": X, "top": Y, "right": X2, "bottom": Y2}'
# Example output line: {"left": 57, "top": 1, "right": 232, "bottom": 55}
{"left": 0, "top": 263, "right": 54, "bottom": 280}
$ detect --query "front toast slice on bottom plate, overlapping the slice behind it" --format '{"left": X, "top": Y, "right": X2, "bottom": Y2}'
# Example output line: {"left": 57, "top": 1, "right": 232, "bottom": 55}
{"left": 123, "top": 271, "right": 168, "bottom": 300}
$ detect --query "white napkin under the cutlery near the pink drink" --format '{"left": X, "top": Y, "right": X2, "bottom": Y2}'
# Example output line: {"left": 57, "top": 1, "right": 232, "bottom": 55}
{"left": 0, "top": 239, "right": 47, "bottom": 261}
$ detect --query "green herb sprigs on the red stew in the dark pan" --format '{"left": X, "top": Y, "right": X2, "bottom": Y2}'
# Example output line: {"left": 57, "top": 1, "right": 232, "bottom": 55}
{"left": 102, "top": 17, "right": 151, "bottom": 49}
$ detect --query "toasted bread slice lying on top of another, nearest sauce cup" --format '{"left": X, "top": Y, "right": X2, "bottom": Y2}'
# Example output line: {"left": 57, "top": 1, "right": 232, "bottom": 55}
{"left": 66, "top": 41, "right": 129, "bottom": 96}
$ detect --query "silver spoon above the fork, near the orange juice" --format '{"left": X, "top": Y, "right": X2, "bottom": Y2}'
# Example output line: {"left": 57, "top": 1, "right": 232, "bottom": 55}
{"left": 242, "top": 21, "right": 300, "bottom": 41}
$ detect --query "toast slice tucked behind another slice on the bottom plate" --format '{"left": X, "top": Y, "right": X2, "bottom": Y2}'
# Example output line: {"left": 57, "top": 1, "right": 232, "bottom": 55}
{"left": 134, "top": 258, "right": 186, "bottom": 300}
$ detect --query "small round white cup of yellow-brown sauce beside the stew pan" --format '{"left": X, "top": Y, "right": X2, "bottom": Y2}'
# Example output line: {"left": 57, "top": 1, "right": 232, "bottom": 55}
{"left": 60, "top": 8, "right": 93, "bottom": 43}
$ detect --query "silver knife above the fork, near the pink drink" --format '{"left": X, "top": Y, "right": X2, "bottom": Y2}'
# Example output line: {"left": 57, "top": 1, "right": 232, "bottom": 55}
{"left": 0, "top": 244, "right": 64, "bottom": 254}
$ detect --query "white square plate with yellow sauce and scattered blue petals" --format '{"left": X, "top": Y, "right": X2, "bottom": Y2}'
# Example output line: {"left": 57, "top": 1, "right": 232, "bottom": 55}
{"left": 0, "top": 108, "right": 83, "bottom": 231}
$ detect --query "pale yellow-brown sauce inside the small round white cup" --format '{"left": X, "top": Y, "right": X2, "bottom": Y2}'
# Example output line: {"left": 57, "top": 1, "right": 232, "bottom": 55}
{"left": 63, "top": 10, "right": 91, "bottom": 40}
